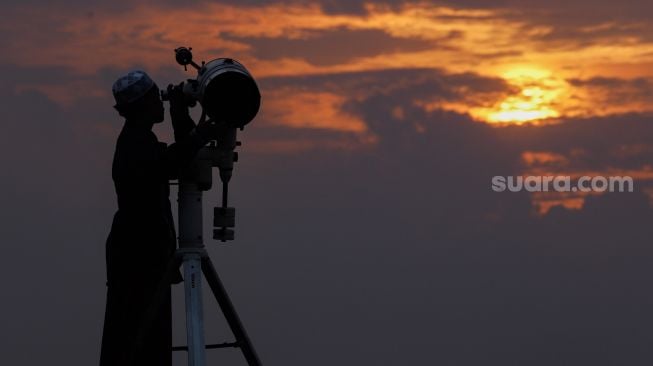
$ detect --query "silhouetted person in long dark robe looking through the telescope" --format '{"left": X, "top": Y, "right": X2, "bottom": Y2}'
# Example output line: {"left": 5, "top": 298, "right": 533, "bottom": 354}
{"left": 100, "top": 71, "right": 211, "bottom": 366}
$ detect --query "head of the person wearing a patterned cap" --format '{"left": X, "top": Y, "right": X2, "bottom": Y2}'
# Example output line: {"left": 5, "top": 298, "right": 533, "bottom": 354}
{"left": 112, "top": 70, "right": 164, "bottom": 124}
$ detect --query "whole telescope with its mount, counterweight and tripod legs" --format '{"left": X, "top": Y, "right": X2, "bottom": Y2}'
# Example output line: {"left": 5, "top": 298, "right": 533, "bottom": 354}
{"left": 155, "top": 47, "right": 261, "bottom": 366}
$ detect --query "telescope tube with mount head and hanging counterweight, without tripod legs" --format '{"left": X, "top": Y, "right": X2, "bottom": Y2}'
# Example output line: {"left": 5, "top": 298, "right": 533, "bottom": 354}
{"left": 161, "top": 47, "right": 261, "bottom": 245}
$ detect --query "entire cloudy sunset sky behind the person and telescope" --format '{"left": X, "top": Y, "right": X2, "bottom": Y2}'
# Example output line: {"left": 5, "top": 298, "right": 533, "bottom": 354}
{"left": 0, "top": 0, "right": 653, "bottom": 366}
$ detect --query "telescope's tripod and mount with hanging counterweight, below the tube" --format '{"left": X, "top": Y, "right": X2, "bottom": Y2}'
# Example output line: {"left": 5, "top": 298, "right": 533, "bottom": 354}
{"left": 141, "top": 128, "right": 261, "bottom": 366}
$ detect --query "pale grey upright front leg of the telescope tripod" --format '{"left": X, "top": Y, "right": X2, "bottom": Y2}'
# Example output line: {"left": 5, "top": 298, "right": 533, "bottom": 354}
{"left": 184, "top": 253, "right": 204, "bottom": 366}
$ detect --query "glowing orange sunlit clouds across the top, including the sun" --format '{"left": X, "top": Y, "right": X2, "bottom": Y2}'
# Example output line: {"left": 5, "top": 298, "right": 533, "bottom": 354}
{"left": 5, "top": 2, "right": 653, "bottom": 127}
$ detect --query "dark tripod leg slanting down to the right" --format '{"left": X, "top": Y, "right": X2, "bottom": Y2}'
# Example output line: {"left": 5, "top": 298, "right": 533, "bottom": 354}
{"left": 202, "top": 256, "right": 261, "bottom": 366}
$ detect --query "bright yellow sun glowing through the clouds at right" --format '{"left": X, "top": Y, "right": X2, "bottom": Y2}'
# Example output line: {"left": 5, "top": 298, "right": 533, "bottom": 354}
{"left": 471, "top": 67, "right": 566, "bottom": 124}
